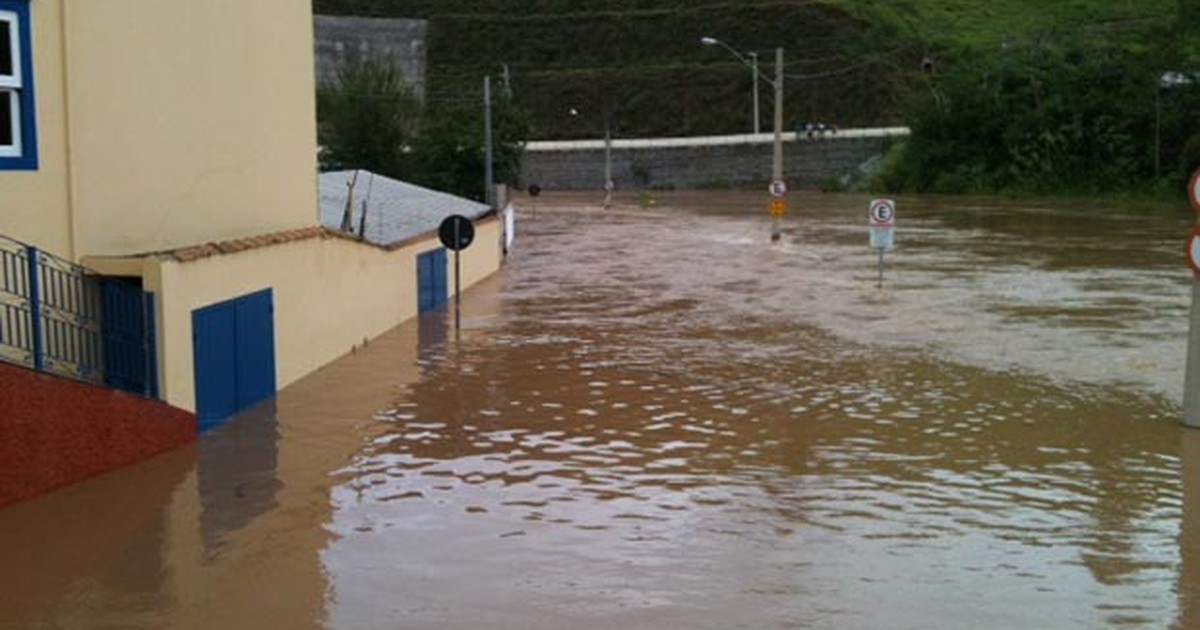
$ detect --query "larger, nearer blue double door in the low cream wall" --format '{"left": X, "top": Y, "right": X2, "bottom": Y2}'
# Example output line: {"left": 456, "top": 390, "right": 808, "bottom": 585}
{"left": 192, "top": 289, "right": 275, "bottom": 431}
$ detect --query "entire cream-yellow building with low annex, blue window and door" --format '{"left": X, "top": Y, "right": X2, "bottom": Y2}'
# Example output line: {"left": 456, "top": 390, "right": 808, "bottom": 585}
{"left": 0, "top": 0, "right": 502, "bottom": 425}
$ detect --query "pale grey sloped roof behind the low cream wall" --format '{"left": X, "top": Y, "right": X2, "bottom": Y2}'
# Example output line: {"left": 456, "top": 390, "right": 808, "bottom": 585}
{"left": 319, "top": 170, "right": 491, "bottom": 246}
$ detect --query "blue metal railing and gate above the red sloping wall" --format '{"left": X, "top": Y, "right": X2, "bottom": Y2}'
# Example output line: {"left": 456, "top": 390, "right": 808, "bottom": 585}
{"left": 0, "top": 236, "right": 158, "bottom": 398}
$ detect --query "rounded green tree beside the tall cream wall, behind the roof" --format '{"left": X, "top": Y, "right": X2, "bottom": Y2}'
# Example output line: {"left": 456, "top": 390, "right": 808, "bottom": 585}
{"left": 317, "top": 59, "right": 421, "bottom": 179}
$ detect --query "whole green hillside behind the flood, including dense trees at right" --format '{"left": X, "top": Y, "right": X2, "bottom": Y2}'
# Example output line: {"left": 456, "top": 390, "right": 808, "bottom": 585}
{"left": 314, "top": 0, "right": 1200, "bottom": 193}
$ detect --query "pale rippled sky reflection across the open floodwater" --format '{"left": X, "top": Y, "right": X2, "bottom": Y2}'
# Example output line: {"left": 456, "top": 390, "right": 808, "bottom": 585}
{"left": 324, "top": 194, "right": 1195, "bottom": 628}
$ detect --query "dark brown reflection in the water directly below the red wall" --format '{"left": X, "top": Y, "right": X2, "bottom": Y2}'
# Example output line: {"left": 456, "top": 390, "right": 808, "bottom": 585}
{"left": 0, "top": 448, "right": 196, "bottom": 629}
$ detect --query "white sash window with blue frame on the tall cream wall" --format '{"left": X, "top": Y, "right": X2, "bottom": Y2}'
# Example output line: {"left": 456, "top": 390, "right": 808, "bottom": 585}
{"left": 0, "top": 0, "right": 37, "bottom": 170}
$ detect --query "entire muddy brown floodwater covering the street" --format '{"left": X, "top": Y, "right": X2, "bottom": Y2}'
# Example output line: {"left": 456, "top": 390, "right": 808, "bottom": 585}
{"left": 0, "top": 193, "right": 1200, "bottom": 630}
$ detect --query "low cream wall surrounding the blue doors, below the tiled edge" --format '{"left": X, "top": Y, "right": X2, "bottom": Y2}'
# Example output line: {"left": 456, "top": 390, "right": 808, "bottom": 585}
{"left": 143, "top": 217, "right": 502, "bottom": 410}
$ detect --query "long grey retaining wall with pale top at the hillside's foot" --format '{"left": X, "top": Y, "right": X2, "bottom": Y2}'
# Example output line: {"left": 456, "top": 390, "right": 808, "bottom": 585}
{"left": 522, "top": 130, "right": 907, "bottom": 190}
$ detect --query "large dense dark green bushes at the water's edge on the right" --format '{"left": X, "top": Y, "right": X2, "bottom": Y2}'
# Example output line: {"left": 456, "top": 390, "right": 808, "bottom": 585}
{"left": 877, "top": 38, "right": 1194, "bottom": 193}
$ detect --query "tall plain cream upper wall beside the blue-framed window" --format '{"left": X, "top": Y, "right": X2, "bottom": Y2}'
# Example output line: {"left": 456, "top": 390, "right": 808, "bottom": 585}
{"left": 0, "top": 0, "right": 317, "bottom": 260}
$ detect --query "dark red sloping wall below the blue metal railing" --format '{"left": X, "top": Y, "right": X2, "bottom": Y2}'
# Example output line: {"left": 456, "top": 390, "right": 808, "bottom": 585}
{"left": 0, "top": 362, "right": 196, "bottom": 506}
